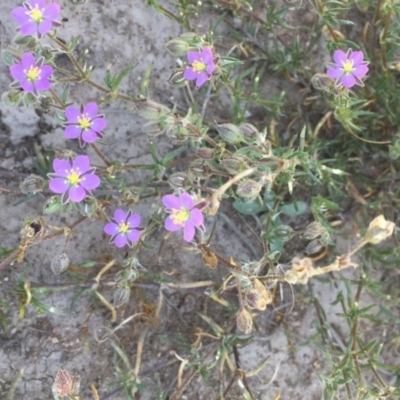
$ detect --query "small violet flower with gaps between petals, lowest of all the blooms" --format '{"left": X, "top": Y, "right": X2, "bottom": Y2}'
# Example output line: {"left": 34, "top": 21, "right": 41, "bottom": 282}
{"left": 104, "top": 210, "right": 142, "bottom": 248}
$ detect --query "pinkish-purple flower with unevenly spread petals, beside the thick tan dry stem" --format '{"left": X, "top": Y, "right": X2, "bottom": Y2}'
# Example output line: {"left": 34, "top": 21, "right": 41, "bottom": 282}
{"left": 162, "top": 192, "right": 204, "bottom": 242}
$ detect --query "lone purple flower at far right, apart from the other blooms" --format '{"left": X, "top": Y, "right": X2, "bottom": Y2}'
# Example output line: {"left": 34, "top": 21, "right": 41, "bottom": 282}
{"left": 327, "top": 49, "right": 368, "bottom": 88}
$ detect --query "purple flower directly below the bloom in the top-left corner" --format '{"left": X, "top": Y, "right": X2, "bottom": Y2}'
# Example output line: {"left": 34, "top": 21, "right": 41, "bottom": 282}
{"left": 10, "top": 53, "right": 53, "bottom": 96}
